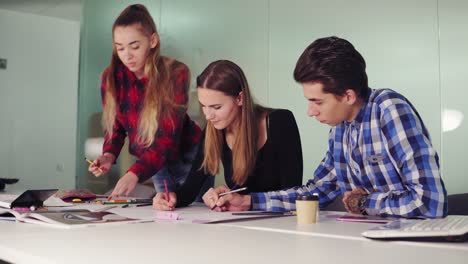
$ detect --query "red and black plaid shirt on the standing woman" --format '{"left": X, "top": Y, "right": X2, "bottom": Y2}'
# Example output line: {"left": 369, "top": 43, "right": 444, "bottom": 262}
{"left": 101, "top": 62, "right": 201, "bottom": 182}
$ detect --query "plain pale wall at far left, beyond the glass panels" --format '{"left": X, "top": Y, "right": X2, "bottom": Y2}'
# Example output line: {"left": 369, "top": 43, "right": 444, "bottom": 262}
{"left": 0, "top": 10, "right": 80, "bottom": 189}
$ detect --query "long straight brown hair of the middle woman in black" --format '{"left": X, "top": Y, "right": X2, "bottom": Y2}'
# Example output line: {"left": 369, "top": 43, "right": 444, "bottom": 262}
{"left": 197, "top": 60, "right": 266, "bottom": 185}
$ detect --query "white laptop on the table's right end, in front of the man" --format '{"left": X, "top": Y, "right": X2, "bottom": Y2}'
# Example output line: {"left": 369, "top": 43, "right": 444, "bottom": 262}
{"left": 362, "top": 215, "right": 468, "bottom": 242}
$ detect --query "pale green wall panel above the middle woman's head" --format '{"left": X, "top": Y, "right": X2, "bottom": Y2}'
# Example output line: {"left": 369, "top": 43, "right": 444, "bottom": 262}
{"left": 160, "top": 0, "right": 269, "bottom": 103}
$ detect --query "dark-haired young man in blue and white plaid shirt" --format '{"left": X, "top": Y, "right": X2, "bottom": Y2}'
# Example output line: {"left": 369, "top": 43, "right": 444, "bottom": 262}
{"left": 213, "top": 37, "right": 447, "bottom": 218}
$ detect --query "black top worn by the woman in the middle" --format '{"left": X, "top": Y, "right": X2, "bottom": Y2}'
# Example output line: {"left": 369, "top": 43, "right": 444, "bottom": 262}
{"left": 176, "top": 109, "right": 303, "bottom": 206}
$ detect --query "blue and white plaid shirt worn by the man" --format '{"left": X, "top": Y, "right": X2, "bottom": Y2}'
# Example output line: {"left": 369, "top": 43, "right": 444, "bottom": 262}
{"left": 251, "top": 89, "right": 447, "bottom": 218}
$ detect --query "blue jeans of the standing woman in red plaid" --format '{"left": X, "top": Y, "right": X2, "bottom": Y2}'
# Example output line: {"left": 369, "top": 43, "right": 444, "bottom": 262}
{"left": 152, "top": 144, "right": 214, "bottom": 202}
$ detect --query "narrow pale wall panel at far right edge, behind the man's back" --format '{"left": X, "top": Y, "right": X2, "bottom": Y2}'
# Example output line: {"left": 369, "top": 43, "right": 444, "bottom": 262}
{"left": 434, "top": 0, "right": 468, "bottom": 193}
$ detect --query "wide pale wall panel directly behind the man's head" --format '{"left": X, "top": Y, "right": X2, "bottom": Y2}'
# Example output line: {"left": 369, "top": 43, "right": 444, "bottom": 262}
{"left": 269, "top": 0, "right": 445, "bottom": 188}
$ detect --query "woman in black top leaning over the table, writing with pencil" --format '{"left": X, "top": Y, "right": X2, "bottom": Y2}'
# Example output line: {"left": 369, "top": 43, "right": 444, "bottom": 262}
{"left": 153, "top": 60, "right": 303, "bottom": 210}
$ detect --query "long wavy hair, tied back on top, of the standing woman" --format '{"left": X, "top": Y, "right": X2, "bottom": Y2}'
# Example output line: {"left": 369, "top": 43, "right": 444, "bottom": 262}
{"left": 102, "top": 4, "right": 181, "bottom": 147}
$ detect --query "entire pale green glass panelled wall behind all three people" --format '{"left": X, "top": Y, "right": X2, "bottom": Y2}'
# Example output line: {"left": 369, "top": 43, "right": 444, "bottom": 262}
{"left": 77, "top": 0, "right": 468, "bottom": 193}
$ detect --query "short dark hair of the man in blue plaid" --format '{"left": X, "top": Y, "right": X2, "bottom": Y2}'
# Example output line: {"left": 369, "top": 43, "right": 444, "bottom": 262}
{"left": 294, "top": 36, "right": 369, "bottom": 98}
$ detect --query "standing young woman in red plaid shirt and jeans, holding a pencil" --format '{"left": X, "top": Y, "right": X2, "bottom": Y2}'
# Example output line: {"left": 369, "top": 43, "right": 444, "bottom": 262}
{"left": 89, "top": 4, "right": 207, "bottom": 197}
